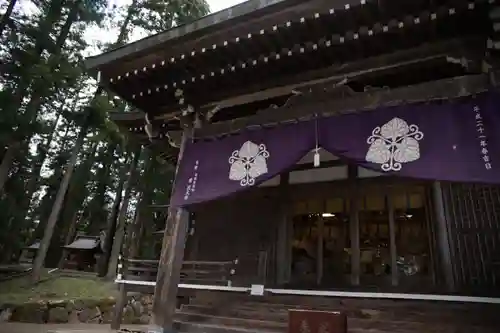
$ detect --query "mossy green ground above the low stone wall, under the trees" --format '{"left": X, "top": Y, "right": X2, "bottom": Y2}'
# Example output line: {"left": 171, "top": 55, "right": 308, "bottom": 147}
{"left": 0, "top": 274, "right": 118, "bottom": 305}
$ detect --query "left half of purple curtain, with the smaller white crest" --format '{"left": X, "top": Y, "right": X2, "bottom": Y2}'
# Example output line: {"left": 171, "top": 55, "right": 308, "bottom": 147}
{"left": 171, "top": 122, "right": 316, "bottom": 206}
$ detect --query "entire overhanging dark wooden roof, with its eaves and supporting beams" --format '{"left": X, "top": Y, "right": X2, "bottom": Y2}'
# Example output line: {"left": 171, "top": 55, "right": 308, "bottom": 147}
{"left": 87, "top": 0, "right": 493, "bottom": 161}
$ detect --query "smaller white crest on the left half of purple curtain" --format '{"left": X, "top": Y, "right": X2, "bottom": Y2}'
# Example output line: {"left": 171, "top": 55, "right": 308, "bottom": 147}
{"left": 229, "top": 141, "right": 269, "bottom": 186}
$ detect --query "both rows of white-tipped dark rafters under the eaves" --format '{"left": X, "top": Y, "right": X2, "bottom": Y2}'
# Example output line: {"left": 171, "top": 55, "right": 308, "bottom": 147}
{"left": 98, "top": 0, "right": 490, "bottom": 115}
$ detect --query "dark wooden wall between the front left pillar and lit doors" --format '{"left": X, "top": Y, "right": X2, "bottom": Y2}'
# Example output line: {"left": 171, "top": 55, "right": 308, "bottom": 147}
{"left": 190, "top": 188, "right": 280, "bottom": 285}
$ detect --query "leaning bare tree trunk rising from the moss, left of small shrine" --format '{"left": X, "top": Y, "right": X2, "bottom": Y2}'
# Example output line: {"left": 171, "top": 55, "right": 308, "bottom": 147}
{"left": 31, "top": 125, "right": 88, "bottom": 283}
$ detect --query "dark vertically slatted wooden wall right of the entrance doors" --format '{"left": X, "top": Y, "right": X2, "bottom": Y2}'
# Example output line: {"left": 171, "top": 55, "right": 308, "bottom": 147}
{"left": 442, "top": 183, "right": 500, "bottom": 295}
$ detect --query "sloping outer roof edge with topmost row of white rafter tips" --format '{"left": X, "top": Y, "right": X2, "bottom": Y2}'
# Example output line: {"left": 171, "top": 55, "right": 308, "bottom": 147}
{"left": 86, "top": 0, "right": 375, "bottom": 72}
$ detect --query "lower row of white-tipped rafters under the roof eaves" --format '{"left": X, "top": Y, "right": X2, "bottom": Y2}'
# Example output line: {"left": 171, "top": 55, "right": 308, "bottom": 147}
{"left": 111, "top": 3, "right": 480, "bottom": 107}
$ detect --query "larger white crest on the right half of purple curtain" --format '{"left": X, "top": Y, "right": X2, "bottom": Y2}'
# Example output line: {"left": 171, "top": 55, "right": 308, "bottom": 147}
{"left": 366, "top": 118, "right": 424, "bottom": 172}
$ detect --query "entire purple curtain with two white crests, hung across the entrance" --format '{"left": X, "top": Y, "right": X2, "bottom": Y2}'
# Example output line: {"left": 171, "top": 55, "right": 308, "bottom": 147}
{"left": 171, "top": 93, "right": 500, "bottom": 206}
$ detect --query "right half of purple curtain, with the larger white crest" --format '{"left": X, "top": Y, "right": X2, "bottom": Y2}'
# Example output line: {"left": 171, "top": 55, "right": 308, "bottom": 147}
{"left": 319, "top": 93, "right": 500, "bottom": 183}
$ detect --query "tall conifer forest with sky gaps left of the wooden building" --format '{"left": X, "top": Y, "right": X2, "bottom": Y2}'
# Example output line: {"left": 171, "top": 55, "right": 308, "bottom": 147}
{"left": 0, "top": 0, "right": 241, "bottom": 282}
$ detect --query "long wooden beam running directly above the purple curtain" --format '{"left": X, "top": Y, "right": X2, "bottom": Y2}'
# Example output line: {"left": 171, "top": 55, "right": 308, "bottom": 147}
{"left": 195, "top": 74, "right": 491, "bottom": 138}
